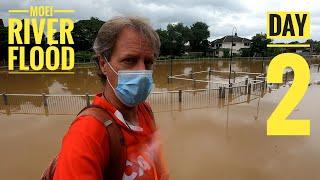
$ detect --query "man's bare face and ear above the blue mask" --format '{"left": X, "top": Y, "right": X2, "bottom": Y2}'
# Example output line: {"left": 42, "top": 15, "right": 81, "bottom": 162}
{"left": 100, "top": 28, "right": 154, "bottom": 87}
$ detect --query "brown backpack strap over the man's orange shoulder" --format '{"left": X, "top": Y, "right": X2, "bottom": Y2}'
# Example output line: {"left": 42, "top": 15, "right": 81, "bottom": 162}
{"left": 78, "top": 105, "right": 127, "bottom": 180}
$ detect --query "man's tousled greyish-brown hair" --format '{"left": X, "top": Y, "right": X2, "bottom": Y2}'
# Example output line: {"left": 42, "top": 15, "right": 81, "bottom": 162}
{"left": 93, "top": 16, "right": 160, "bottom": 84}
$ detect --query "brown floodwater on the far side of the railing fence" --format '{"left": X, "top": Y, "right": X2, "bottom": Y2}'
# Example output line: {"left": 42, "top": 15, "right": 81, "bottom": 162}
{"left": 0, "top": 60, "right": 274, "bottom": 94}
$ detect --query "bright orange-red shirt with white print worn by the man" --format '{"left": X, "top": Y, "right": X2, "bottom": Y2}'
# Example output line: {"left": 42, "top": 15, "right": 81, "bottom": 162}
{"left": 54, "top": 93, "right": 167, "bottom": 180}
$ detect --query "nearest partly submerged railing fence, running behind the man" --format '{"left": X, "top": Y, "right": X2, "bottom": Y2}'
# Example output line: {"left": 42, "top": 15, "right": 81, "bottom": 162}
{"left": 0, "top": 81, "right": 278, "bottom": 115}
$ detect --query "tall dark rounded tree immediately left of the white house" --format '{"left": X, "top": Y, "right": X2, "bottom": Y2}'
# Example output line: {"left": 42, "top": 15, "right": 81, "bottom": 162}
{"left": 189, "top": 22, "right": 210, "bottom": 52}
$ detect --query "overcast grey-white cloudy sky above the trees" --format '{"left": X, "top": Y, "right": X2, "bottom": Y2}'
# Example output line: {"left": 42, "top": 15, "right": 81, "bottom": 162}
{"left": 0, "top": 0, "right": 320, "bottom": 40}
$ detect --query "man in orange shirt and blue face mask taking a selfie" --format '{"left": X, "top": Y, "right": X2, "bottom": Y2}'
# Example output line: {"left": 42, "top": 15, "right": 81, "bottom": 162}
{"left": 54, "top": 17, "right": 168, "bottom": 180}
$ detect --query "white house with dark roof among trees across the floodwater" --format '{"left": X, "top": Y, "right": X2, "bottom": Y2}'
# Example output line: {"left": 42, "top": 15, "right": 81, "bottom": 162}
{"left": 211, "top": 33, "right": 251, "bottom": 57}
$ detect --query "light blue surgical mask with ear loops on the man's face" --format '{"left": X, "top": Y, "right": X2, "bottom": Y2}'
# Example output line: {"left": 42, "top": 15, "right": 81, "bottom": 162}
{"left": 105, "top": 58, "right": 153, "bottom": 107}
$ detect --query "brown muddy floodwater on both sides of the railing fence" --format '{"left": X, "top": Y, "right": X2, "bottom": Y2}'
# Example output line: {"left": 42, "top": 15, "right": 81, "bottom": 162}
{"left": 0, "top": 58, "right": 320, "bottom": 180}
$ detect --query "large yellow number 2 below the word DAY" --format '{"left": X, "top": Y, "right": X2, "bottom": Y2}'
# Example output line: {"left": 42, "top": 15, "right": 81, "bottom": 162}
{"left": 267, "top": 53, "right": 310, "bottom": 135}
